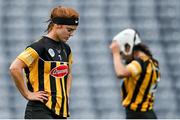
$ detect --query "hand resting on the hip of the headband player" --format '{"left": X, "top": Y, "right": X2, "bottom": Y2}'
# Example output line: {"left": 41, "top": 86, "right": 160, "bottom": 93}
{"left": 27, "top": 91, "right": 48, "bottom": 102}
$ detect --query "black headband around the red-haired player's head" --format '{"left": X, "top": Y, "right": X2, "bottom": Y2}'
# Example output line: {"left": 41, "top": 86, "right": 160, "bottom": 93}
{"left": 52, "top": 17, "right": 79, "bottom": 25}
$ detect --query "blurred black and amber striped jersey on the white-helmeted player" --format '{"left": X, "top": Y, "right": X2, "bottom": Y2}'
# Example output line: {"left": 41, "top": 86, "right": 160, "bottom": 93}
{"left": 121, "top": 57, "right": 160, "bottom": 112}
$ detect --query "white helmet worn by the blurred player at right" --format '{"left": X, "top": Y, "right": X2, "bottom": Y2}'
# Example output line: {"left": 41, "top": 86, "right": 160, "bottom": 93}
{"left": 113, "top": 28, "right": 141, "bottom": 55}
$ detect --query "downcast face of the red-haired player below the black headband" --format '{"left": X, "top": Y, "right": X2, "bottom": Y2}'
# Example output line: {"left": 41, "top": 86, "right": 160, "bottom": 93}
{"left": 57, "top": 25, "right": 77, "bottom": 42}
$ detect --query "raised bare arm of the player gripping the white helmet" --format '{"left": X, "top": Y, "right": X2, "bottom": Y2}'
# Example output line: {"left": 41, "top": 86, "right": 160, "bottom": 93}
{"left": 110, "top": 41, "right": 131, "bottom": 78}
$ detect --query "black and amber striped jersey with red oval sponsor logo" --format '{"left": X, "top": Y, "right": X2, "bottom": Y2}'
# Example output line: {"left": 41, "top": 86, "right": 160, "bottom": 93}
{"left": 18, "top": 36, "right": 72, "bottom": 117}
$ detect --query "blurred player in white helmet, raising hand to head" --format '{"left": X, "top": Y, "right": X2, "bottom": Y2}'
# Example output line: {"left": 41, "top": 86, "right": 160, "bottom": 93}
{"left": 110, "top": 29, "right": 160, "bottom": 119}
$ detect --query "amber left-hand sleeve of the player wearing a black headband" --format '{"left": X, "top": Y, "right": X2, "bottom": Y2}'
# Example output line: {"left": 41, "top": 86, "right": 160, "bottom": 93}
{"left": 17, "top": 47, "right": 39, "bottom": 67}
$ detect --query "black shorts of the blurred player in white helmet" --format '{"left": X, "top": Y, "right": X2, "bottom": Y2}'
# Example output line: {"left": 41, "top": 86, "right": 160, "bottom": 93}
{"left": 126, "top": 108, "right": 157, "bottom": 119}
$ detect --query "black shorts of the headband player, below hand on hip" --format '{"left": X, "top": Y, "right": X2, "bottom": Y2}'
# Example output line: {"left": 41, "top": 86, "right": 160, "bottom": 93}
{"left": 24, "top": 101, "right": 67, "bottom": 119}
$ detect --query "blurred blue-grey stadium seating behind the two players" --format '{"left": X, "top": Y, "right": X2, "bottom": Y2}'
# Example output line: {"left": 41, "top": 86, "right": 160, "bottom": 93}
{"left": 0, "top": 0, "right": 180, "bottom": 119}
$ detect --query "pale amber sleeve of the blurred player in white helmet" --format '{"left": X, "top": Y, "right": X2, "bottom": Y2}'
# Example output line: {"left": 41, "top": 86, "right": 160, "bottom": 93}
{"left": 127, "top": 60, "right": 142, "bottom": 77}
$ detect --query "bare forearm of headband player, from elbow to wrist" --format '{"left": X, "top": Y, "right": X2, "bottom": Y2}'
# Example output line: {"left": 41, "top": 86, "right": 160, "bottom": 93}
{"left": 10, "top": 66, "right": 29, "bottom": 99}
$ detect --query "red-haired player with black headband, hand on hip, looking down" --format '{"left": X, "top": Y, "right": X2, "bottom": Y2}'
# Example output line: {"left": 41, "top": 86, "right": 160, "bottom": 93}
{"left": 10, "top": 6, "right": 79, "bottom": 119}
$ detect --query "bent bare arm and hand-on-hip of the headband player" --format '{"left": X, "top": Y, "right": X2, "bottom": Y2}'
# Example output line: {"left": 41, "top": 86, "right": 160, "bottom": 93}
{"left": 9, "top": 47, "right": 48, "bottom": 102}
